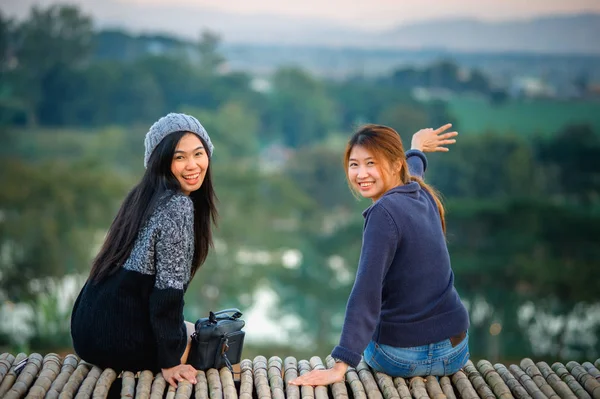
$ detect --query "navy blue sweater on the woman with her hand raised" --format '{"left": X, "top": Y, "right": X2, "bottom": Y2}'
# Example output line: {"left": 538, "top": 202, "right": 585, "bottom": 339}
{"left": 332, "top": 150, "right": 469, "bottom": 367}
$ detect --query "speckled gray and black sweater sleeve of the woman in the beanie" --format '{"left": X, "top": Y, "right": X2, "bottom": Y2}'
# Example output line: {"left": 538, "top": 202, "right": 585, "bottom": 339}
{"left": 150, "top": 198, "right": 193, "bottom": 369}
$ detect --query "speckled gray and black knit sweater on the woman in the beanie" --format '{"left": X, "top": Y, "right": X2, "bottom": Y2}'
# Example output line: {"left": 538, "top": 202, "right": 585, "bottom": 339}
{"left": 71, "top": 192, "right": 194, "bottom": 371}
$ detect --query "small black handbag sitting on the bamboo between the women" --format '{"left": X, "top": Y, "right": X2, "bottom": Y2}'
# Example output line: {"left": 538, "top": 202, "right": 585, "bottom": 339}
{"left": 187, "top": 309, "right": 246, "bottom": 372}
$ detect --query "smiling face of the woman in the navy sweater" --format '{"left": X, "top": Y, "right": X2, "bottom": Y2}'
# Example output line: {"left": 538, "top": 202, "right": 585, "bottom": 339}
{"left": 348, "top": 145, "right": 402, "bottom": 201}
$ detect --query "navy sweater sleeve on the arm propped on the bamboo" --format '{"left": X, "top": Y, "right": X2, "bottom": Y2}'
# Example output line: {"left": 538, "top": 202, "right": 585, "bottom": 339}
{"left": 331, "top": 204, "right": 399, "bottom": 367}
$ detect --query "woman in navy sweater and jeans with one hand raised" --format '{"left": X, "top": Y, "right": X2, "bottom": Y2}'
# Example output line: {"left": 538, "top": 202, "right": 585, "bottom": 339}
{"left": 292, "top": 124, "right": 469, "bottom": 385}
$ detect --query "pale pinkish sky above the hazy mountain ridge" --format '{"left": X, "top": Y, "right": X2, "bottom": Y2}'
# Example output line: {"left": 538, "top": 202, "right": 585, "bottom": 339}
{"left": 0, "top": 0, "right": 600, "bottom": 29}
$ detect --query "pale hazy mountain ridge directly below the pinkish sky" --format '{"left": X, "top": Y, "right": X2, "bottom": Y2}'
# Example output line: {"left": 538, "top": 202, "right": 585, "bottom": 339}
{"left": 89, "top": 4, "right": 600, "bottom": 54}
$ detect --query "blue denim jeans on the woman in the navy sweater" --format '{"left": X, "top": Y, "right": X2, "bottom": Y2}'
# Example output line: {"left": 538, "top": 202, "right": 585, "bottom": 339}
{"left": 363, "top": 332, "right": 469, "bottom": 378}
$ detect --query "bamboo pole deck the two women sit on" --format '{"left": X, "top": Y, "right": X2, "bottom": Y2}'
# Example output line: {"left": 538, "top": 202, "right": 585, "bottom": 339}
{"left": 0, "top": 353, "right": 600, "bottom": 399}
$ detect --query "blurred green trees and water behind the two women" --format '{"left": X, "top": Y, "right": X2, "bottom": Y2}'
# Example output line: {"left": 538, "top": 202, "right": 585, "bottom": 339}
{"left": 0, "top": 6, "right": 600, "bottom": 360}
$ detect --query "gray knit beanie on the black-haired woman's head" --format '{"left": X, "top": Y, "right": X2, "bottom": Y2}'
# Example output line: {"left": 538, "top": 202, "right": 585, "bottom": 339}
{"left": 144, "top": 113, "right": 214, "bottom": 168}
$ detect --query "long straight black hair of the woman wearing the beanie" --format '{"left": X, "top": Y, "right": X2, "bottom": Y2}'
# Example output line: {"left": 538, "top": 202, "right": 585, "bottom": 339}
{"left": 89, "top": 131, "right": 218, "bottom": 282}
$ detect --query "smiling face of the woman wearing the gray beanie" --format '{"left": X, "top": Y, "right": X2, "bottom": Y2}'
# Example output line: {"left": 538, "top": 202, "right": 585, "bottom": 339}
{"left": 171, "top": 133, "right": 209, "bottom": 195}
